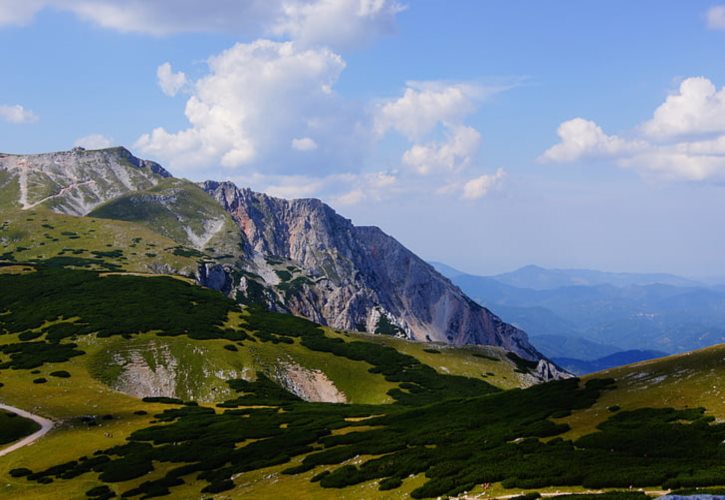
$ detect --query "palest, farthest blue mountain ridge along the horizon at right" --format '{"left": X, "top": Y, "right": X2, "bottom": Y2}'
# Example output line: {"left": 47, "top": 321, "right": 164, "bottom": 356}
{"left": 492, "top": 265, "right": 700, "bottom": 290}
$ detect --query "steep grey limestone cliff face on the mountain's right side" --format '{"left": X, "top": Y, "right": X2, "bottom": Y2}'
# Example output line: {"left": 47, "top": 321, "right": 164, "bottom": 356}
{"left": 202, "top": 181, "right": 546, "bottom": 362}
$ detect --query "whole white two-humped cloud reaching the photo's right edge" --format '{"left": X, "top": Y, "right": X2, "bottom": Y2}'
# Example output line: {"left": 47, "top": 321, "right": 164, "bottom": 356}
{"left": 540, "top": 77, "right": 725, "bottom": 181}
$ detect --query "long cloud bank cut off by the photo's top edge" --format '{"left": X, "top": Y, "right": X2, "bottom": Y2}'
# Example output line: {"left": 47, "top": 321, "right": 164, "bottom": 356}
{"left": 0, "top": 0, "right": 404, "bottom": 47}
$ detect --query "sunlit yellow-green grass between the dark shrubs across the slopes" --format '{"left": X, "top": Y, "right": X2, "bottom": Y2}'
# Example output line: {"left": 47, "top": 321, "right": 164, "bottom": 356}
{"left": 0, "top": 229, "right": 725, "bottom": 498}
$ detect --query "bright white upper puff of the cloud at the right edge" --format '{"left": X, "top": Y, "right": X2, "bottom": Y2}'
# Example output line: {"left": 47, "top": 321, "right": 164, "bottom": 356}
{"left": 642, "top": 77, "right": 725, "bottom": 139}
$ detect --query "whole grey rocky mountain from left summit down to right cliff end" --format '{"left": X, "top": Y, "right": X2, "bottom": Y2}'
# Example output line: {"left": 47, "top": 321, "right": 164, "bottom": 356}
{"left": 0, "top": 148, "right": 556, "bottom": 366}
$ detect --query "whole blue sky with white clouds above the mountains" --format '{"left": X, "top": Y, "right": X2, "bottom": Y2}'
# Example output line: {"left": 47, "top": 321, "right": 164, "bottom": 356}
{"left": 0, "top": 0, "right": 725, "bottom": 277}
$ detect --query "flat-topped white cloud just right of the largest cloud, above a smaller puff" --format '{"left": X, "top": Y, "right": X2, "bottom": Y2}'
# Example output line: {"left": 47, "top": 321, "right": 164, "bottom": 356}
{"left": 375, "top": 82, "right": 490, "bottom": 140}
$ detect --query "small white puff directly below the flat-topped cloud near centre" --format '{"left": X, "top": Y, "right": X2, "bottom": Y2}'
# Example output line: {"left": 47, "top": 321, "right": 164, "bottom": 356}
{"left": 403, "top": 125, "right": 481, "bottom": 175}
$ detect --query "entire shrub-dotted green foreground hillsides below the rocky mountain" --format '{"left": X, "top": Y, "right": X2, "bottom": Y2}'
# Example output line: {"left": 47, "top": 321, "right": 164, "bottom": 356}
{"left": 0, "top": 262, "right": 725, "bottom": 498}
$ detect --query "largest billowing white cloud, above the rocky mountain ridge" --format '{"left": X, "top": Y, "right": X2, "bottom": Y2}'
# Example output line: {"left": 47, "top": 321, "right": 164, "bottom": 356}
{"left": 136, "top": 40, "right": 355, "bottom": 173}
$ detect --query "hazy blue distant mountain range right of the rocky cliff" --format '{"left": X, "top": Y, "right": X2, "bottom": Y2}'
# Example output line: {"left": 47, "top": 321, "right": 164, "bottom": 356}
{"left": 432, "top": 263, "right": 725, "bottom": 367}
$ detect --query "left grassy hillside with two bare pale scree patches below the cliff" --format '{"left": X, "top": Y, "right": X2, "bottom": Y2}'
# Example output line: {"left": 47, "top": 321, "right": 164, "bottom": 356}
{"left": 0, "top": 258, "right": 556, "bottom": 497}
